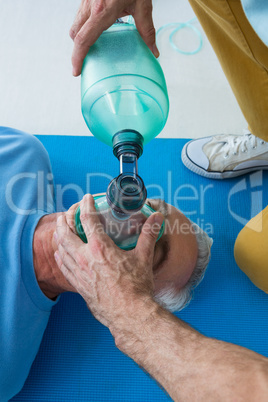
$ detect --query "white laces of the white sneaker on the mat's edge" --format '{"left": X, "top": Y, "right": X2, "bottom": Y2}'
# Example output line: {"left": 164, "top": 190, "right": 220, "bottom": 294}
{"left": 224, "top": 133, "right": 267, "bottom": 158}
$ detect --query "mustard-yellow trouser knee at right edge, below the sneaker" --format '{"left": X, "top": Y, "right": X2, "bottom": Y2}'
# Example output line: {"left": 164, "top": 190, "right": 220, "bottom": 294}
{"left": 234, "top": 206, "right": 268, "bottom": 293}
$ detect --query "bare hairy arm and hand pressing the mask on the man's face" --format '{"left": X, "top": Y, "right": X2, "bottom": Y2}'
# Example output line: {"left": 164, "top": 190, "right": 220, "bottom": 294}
{"left": 55, "top": 196, "right": 268, "bottom": 401}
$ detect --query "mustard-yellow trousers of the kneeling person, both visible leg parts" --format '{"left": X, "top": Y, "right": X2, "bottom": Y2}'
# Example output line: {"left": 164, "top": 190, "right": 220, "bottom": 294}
{"left": 189, "top": 0, "right": 268, "bottom": 293}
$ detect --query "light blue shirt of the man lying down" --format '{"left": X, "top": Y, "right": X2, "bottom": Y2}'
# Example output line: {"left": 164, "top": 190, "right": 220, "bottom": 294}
{"left": 0, "top": 127, "right": 58, "bottom": 402}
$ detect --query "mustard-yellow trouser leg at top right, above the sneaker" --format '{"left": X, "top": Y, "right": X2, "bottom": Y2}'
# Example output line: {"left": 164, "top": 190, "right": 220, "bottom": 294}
{"left": 189, "top": 0, "right": 268, "bottom": 141}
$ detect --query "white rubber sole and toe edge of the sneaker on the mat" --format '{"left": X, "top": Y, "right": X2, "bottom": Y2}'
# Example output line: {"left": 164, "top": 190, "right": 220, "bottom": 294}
{"left": 181, "top": 140, "right": 268, "bottom": 180}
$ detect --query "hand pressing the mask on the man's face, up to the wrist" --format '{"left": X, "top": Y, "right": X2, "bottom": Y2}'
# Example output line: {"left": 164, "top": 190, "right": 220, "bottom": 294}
{"left": 54, "top": 195, "right": 163, "bottom": 334}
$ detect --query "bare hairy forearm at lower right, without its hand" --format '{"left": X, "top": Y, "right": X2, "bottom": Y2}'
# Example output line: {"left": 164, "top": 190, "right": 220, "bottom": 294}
{"left": 110, "top": 306, "right": 268, "bottom": 402}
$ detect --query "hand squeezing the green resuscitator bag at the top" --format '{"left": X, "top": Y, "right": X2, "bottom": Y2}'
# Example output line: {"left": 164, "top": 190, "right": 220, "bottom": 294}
{"left": 70, "top": 0, "right": 159, "bottom": 76}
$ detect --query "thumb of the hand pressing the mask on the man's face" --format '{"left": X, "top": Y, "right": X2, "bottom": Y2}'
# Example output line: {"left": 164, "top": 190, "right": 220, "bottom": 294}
{"left": 135, "top": 212, "right": 164, "bottom": 262}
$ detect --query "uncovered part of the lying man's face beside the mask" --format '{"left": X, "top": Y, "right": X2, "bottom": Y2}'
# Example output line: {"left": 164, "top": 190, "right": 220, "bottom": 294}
{"left": 146, "top": 199, "right": 198, "bottom": 293}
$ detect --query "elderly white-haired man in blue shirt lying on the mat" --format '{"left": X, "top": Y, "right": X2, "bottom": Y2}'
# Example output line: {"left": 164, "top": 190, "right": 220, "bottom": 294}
{"left": 0, "top": 127, "right": 212, "bottom": 401}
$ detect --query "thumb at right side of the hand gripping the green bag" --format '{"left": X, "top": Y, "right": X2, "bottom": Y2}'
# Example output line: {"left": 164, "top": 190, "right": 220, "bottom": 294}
{"left": 133, "top": 0, "right": 159, "bottom": 57}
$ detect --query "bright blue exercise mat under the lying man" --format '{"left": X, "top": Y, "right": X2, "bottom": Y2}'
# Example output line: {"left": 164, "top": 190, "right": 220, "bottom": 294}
{"left": 12, "top": 136, "right": 268, "bottom": 402}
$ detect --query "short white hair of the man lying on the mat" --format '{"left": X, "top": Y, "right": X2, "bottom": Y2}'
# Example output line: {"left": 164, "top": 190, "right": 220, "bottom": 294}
{"left": 155, "top": 219, "right": 213, "bottom": 312}
